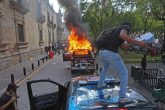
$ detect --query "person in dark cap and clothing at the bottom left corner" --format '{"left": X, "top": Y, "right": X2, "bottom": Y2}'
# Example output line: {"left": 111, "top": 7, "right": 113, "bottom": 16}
{"left": 0, "top": 84, "right": 17, "bottom": 110}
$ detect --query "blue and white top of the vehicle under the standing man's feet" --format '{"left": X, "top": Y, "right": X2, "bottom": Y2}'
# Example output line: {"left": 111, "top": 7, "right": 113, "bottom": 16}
{"left": 67, "top": 76, "right": 157, "bottom": 110}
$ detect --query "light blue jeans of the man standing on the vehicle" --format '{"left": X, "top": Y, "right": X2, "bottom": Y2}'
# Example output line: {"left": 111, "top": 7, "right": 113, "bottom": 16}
{"left": 98, "top": 50, "right": 128, "bottom": 99}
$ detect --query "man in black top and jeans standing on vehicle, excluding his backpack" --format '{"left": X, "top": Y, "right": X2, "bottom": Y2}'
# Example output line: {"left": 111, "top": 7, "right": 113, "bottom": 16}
{"left": 96, "top": 22, "right": 147, "bottom": 104}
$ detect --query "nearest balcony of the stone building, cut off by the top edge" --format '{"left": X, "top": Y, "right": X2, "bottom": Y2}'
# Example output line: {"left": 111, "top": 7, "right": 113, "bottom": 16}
{"left": 10, "top": 0, "right": 29, "bottom": 14}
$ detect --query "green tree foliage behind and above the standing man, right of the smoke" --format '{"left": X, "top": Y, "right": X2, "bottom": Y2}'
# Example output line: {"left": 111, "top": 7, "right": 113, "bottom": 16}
{"left": 80, "top": 0, "right": 165, "bottom": 39}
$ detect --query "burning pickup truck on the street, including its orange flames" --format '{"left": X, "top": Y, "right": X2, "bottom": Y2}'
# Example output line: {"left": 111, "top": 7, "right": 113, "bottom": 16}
{"left": 63, "top": 28, "right": 95, "bottom": 73}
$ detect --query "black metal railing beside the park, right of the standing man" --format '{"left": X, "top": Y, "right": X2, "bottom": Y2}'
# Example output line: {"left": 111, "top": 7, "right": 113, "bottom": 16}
{"left": 131, "top": 66, "right": 165, "bottom": 90}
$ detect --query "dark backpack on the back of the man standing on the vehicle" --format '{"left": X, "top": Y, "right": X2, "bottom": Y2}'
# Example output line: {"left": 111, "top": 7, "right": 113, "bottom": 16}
{"left": 95, "top": 27, "right": 117, "bottom": 50}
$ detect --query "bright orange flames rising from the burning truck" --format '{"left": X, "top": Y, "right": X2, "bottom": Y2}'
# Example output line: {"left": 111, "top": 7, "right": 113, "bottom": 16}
{"left": 68, "top": 28, "right": 92, "bottom": 55}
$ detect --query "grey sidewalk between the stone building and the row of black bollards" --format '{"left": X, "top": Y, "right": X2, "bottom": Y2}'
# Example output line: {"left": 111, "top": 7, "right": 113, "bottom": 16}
{"left": 0, "top": 53, "right": 47, "bottom": 94}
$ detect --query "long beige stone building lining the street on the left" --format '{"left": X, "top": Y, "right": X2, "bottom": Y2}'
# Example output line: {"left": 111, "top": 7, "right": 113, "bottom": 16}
{"left": 0, "top": 0, "right": 58, "bottom": 70}
